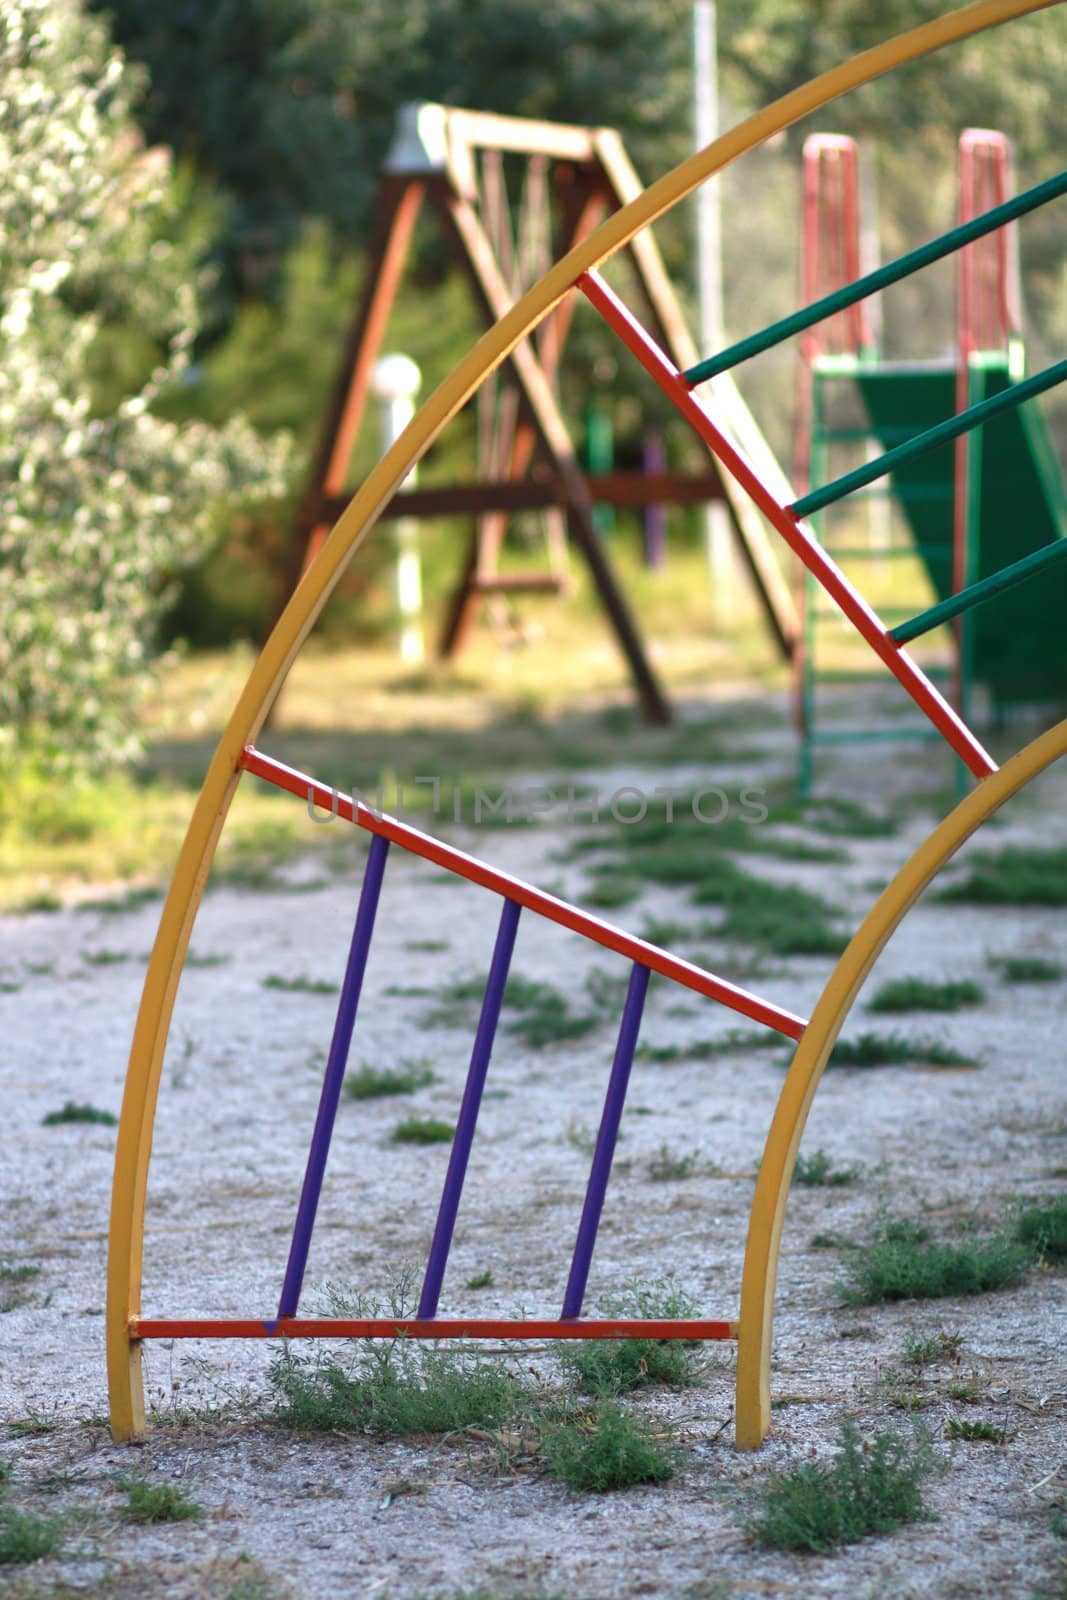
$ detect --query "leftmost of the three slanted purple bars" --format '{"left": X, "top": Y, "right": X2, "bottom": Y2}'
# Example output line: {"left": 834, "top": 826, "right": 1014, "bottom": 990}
{"left": 278, "top": 834, "right": 389, "bottom": 1317}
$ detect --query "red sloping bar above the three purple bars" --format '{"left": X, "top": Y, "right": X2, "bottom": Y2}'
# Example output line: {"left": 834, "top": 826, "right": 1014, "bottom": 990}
{"left": 242, "top": 744, "right": 808, "bottom": 1038}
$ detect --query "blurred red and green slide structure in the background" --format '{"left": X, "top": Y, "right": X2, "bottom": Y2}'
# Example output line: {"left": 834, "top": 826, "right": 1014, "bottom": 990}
{"left": 795, "top": 128, "right": 1067, "bottom": 794}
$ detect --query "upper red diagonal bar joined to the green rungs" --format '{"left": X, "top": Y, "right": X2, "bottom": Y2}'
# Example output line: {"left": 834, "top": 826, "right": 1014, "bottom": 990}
{"left": 577, "top": 272, "right": 997, "bottom": 778}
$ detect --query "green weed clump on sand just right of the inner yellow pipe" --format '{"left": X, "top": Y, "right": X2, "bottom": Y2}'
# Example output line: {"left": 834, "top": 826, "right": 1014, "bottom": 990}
{"left": 838, "top": 1216, "right": 1033, "bottom": 1306}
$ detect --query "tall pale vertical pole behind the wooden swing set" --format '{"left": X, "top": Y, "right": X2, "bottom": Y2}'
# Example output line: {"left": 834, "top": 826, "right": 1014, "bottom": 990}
{"left": 693, "top": 0, "right": 737, "bottom": 624}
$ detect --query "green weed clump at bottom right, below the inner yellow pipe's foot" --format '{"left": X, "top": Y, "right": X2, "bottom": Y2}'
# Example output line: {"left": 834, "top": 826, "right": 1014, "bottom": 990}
{"left": 752, "top": 1422, "right": 933, "bottom": 1552}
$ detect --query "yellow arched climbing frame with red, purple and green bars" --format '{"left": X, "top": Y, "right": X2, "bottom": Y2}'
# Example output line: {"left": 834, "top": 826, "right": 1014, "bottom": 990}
{"left": 107, "top": 0, "right": 1067, "bottom": 1448}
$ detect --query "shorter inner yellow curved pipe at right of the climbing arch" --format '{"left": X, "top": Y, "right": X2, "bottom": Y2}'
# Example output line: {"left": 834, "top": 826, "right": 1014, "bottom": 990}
{"left": 736, "top": 722, "right": 1067, "bottom": 1450}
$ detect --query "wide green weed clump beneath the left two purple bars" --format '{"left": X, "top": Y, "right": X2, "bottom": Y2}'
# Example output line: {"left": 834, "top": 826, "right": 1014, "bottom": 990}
{"left": 270, "top": 1339, "right": 525, "bottom": 1438}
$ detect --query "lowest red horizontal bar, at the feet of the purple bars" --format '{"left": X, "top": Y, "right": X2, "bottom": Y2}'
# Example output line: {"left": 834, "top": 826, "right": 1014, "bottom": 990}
{"left": 130, "top": 1317, "right": 737, "bottom": 1339}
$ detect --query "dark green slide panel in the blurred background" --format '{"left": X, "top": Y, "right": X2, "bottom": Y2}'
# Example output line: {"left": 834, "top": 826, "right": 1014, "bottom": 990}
{"left": 854, "top": 355, "right": 1067, "bottom": 706}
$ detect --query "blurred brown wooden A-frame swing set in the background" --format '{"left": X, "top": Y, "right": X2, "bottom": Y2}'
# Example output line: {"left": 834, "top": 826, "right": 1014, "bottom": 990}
{"left": 283, "top": 102, "right": 800, "bottom": 722}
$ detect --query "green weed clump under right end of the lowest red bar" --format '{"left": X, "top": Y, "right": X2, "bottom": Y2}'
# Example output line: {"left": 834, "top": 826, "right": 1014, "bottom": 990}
{"left": 557, "top": 1278, "right": 697, "bottom": 1395}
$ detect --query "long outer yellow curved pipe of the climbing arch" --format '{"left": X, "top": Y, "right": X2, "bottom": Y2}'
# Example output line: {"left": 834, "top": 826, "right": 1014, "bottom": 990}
{"left": 107, "top": 0, "right": 1057, "bottom": 1440}
